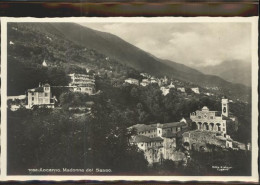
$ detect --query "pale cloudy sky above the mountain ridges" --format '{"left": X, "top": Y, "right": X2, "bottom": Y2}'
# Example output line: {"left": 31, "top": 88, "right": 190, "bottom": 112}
{"left": 82, "top": 23, "right": 251, "bottom": 68}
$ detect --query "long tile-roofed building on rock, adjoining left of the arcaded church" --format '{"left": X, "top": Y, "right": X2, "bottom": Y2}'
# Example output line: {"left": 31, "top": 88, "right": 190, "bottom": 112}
{"left": 130, "top": 122, "right": 187, "bottom": 164}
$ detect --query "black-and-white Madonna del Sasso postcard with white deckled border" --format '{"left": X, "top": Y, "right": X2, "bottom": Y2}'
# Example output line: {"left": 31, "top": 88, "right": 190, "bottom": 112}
{"left": 1, "top": 17, "right": 258, "bottom": 182}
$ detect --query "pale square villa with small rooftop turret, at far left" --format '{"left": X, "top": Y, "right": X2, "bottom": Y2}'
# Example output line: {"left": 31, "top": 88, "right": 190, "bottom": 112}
{"left": 27, "top": 84, "right": 54, "bottom": 109}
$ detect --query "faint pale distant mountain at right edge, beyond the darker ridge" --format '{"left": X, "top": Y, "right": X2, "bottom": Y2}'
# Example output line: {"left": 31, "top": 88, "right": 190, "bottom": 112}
{"left": 198, "top": 61, "right": 251, "bottom": 87}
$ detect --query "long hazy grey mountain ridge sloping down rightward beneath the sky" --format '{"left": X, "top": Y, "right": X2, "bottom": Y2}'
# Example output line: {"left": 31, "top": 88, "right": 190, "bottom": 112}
{"left": 8, "top": 23, "right": 251, "bottom": 102}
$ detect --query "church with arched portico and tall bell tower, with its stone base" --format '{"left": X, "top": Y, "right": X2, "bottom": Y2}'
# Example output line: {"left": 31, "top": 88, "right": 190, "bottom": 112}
{"left": 182, "top": 98, "right": 245, "bottom": 151}
